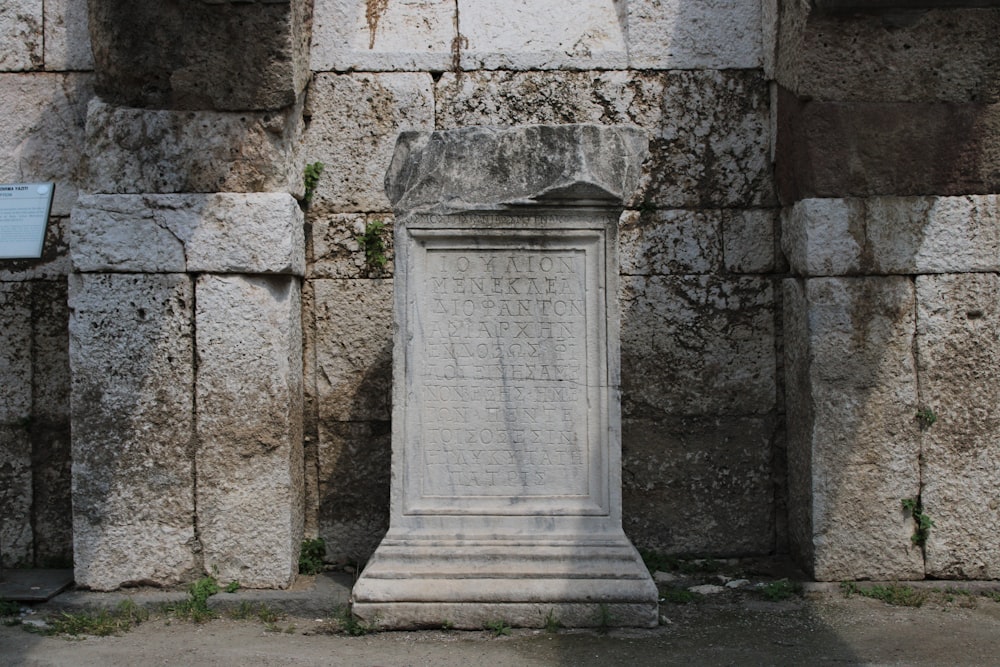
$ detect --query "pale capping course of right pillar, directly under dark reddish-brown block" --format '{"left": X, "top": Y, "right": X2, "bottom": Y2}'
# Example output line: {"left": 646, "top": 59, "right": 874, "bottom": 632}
{"left": 782, "top": 195, "right": 1000, "bottom": 276}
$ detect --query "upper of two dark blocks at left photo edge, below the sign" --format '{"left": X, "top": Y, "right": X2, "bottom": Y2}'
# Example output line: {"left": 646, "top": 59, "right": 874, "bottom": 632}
{"left": 0, "top": 282, "right": 33, "bottom": 425}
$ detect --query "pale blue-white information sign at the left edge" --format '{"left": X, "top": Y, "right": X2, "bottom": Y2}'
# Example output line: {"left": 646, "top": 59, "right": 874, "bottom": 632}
{"left": 0, "top": 183, "right": 55, "bottom": 259}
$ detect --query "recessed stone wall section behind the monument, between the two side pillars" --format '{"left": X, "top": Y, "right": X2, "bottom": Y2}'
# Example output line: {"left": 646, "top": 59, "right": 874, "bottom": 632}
{"left": 299, "top": 0, "right": 784, "bottom": 561}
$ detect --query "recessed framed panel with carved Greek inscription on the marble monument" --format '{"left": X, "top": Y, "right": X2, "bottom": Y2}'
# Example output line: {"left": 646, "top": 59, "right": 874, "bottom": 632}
{"left": 408, "top": 233, "right": 606, "bottom": 513}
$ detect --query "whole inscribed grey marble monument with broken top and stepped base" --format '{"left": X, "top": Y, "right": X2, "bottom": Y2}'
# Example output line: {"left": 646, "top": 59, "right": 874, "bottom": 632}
{"left": 353, "top": 125, "right": 658, "bottom": 629}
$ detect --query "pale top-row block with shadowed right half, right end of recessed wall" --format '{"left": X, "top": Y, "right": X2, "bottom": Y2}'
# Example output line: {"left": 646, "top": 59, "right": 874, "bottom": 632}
{"left": 628, "top": 0, "right": 763, "bottom": 69}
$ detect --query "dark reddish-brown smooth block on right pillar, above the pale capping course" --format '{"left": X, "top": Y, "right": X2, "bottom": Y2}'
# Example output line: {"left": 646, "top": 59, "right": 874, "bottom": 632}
{"left": 775, "top": 94, "right": 1000, "bottom": 204}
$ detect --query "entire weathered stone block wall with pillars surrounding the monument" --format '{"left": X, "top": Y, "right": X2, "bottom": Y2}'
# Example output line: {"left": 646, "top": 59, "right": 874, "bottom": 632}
{"left": 0, "top": 0, "right": 1000, "bottom": 588}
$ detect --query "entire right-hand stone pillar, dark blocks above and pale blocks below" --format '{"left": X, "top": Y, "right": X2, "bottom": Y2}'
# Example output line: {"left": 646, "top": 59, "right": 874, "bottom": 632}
{"left": 776, "top": 2, "right": 1000, "bottom": 580}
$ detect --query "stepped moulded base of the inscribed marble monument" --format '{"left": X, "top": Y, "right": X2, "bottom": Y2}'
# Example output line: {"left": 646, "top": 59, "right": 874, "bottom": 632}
{"left": 352, "top": 534, "right": 659, "bottom": 630}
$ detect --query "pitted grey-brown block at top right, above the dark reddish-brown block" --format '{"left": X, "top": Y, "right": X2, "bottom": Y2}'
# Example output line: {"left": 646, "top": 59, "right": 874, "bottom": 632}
{"left": 777, "top": 3, "right": 1000, "bottom": 103}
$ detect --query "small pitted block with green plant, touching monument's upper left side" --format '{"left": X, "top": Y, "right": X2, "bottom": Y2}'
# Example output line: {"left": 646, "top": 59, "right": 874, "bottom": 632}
{"left": 309, "top": 213, "right": 393, "bottom": 278}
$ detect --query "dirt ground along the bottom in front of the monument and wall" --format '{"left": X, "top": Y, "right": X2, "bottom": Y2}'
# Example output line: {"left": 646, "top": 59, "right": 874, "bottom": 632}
{"left": 0, "top": 583, "right": 1000, "bottom": 667}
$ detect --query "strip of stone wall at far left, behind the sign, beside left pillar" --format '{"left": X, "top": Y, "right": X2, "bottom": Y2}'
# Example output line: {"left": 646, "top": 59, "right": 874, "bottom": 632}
{"left": 0, "top": 0, "right": 93, "bottom": 567}
